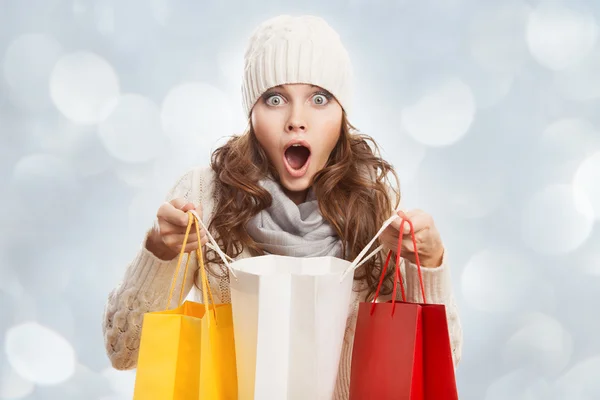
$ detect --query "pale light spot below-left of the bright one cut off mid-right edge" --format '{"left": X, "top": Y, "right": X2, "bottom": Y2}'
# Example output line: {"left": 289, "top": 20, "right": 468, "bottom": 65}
{"left": 521, "top": 184, "right": 593, "bottom": 255}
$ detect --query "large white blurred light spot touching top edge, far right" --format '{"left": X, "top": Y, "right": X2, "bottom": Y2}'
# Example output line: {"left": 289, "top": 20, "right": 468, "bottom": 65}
{"left": 526, "top": 3, "right": 598, "bottom": 70}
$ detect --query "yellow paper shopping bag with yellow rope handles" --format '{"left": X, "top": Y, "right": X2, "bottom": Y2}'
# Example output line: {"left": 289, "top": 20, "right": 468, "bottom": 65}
{"left": 133, "top": 212, "right": 237, "bottom": 400}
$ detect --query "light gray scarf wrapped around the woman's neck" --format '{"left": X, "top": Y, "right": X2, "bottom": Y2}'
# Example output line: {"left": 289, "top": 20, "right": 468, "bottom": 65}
{"left": 246, "top": 178, "right": 342, "bottom": 257}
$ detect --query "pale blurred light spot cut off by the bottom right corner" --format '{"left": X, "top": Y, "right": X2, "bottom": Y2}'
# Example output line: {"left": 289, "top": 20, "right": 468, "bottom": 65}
{"left": 556, "top": 355, "right": 600, "bottom": 400}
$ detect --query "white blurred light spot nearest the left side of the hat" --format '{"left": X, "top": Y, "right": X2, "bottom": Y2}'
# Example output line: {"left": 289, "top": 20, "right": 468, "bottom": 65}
{"left": 161, "top": 82, "right": 236, "bottom": 153}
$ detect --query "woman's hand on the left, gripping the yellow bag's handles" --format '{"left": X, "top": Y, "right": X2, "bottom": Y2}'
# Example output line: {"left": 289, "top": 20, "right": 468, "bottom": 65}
{"left": 146, "top": 198, "right": 208, "bottom": 260}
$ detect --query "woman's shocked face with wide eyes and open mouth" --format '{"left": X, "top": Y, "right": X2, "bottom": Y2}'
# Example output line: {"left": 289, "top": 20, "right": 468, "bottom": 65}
{"left": 251, "top": 84, "right": 342, "bottom": 204}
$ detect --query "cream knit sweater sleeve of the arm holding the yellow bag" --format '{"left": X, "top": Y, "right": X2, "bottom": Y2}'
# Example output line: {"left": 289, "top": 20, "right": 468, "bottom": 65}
{"left": 102, "top": 170, "right": 204, "bottom": 370}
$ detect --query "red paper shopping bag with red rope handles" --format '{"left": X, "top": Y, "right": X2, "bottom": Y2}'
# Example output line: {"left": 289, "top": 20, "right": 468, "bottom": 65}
{"left": 350, "top": 219, "right": 458, "bottom": 400}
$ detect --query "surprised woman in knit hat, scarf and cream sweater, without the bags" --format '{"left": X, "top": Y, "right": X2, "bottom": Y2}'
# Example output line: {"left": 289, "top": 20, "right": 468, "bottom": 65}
{"left": 104, "top": 16, "right": 462, "bottom": 399}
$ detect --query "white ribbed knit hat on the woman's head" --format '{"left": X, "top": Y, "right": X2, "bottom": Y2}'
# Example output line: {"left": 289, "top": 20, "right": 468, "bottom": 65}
{"left": 242, "top": 15, "right": 353, "bottom": 117}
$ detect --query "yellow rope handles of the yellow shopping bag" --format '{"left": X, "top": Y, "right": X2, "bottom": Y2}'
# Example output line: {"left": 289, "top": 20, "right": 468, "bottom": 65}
{"left": 165, "top": 211, "right": 217, "bottom": 323}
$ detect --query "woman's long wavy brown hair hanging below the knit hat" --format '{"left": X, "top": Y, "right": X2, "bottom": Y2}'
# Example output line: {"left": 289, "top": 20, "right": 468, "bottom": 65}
{"left": 206, "top": 113, "right": 400, "bottom": 298}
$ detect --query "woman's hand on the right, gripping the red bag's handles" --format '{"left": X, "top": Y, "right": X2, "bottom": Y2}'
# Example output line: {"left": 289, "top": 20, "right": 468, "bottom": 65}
{"left": 381, "top": 210, "right": 444, "bottom": 268}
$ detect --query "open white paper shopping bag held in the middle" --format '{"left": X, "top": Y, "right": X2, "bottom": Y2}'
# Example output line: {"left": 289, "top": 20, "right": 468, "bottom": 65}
{"left": 198, "top": 211, "right": 398, "bottom": 400}
